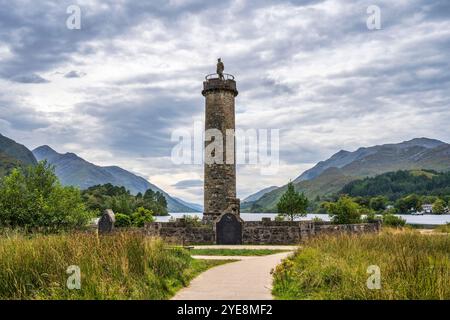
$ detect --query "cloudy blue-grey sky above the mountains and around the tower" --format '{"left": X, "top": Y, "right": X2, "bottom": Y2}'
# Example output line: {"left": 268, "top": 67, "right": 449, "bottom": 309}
{"left": 0, "top": 0, "right": 450, "bottom": 202}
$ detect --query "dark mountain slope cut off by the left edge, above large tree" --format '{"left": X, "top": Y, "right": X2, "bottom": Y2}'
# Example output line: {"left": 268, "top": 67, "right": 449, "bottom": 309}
{"left": 0, "top": 134, "right": 37, "bottom": 177}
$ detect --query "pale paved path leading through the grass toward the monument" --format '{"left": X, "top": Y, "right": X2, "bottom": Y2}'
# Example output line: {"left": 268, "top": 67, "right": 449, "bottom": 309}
{"left": 173, "top": 251, "right": 291, "bottom": 300}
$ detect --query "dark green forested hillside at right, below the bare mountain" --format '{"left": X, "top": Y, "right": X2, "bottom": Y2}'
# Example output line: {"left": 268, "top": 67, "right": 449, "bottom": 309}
{"left": 339, "top": 170, "right": 450, "bottom": 201}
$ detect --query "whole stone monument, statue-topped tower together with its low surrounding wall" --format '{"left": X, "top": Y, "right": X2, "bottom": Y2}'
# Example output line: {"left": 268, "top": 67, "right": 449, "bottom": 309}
{"left": 143, "top": 59, "right": 381, "bottom": 245}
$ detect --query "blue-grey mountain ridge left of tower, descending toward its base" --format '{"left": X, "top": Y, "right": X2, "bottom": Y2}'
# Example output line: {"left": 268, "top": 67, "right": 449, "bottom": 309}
{"left": 33, "top": 146, "right": 195, "bottom": 212}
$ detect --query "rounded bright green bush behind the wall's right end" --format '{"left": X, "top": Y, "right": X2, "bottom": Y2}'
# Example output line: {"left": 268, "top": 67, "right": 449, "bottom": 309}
{"left": 324, "top": 196, "right": 361, "bottom": 224}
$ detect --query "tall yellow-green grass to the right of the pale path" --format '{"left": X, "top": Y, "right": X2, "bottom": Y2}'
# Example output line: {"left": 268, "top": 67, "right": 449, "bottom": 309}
{"left": 273, "top": 230, "right": 450, "bottom": 300}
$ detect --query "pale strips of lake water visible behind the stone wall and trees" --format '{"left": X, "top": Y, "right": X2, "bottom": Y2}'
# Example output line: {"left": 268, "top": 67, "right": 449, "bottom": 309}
{"left": 156, "top": 213, "right": 450, "bottom": 225}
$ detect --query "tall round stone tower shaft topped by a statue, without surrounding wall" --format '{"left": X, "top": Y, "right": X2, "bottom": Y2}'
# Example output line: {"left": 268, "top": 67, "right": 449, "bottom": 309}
{"left": 202, "top": 60, "right": 240, "bottom": 222}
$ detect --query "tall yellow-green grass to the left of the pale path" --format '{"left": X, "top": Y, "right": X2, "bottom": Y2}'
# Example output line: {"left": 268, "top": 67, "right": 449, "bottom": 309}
{"left": 0, "top": 233, "right": 230, "bottom": 299}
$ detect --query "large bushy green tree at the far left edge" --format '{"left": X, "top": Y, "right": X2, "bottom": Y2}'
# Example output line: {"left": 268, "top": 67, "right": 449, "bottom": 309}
{"left": 0, "top": 161, "right": 93, "bottom": 232}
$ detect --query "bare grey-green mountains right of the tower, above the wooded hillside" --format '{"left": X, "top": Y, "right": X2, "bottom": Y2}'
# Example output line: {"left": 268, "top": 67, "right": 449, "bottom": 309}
{"left": 244, "top": 138, "right": 450, "bottom": 212}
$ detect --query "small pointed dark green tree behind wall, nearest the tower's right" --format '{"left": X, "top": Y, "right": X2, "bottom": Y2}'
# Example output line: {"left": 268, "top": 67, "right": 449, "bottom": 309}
{"left": 277, "top": 182, "right": 309, "bottom": 221}
